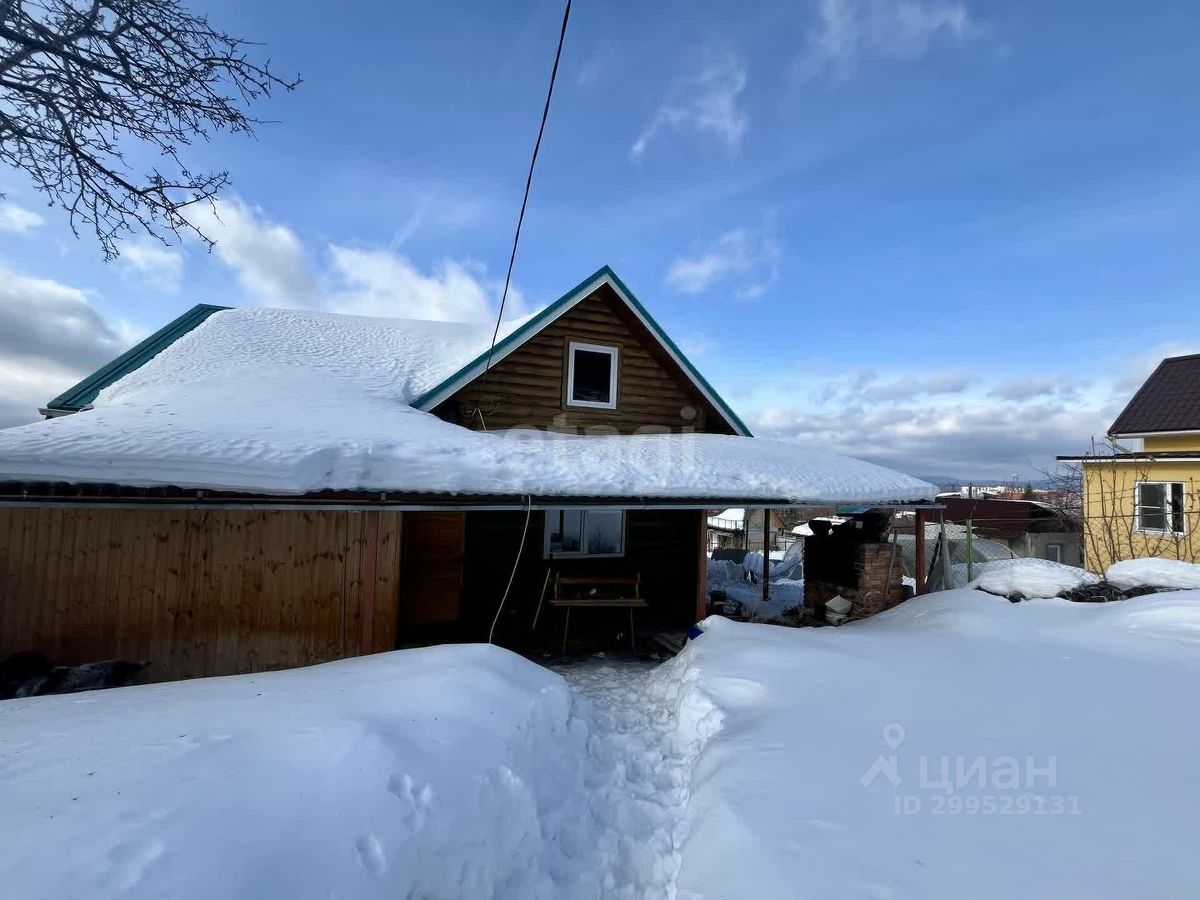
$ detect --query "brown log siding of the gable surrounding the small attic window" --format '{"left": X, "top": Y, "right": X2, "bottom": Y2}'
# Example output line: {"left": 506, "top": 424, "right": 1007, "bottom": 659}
{"left": 434, "top": 286, "right": 732, "bottom": 434}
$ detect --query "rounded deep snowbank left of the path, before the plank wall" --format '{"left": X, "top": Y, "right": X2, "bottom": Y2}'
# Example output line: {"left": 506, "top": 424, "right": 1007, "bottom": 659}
{"left": 0, "top": 646, "right": 601, "bottom": 900}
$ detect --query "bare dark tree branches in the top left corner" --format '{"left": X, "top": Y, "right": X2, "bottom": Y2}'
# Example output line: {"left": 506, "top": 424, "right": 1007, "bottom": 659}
{"left": 0, "top": 0, "right": 299, "bottom": 259}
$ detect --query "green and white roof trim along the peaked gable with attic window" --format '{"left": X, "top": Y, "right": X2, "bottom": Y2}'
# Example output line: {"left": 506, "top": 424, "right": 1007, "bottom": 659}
{"left": 413, "top": 265, "right": 752, "bottom": 437}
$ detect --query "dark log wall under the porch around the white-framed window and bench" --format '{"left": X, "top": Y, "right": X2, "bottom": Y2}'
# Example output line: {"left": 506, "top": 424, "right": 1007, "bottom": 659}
{"left": 461, "top": 510, "right": 702, "bottom": 647}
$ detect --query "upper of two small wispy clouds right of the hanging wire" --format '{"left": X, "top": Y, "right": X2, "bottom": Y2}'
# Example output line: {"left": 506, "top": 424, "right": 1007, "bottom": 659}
{"left": 630, "top": 52, "right": 749, "bottom": 160}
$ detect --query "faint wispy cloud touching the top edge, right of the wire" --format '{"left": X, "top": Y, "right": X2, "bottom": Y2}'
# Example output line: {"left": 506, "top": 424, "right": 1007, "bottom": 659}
{"left": 796, "top": 0, "right": 983, "bottom": 79}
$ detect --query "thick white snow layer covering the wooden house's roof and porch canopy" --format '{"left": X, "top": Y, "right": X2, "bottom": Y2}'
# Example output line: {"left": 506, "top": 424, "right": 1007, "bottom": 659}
{"left": 0, "top": 274, "right": 934, "bottom": 503}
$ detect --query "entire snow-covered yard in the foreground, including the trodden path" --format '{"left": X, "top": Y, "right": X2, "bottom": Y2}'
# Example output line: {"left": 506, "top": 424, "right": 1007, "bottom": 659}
{"left": 0, "top": 590, "right": 1200, "bottom": 900}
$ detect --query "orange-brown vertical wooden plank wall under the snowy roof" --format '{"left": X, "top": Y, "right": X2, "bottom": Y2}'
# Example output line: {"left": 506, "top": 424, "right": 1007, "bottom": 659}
{"left": 0, "top": 508, "right": 401, "bottom": 680}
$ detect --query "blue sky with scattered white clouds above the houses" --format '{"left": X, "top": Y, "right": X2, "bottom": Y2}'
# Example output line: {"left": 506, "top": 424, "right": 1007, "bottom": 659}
{"left": 0, "top": 0, "right": 1200, "bottom": 478}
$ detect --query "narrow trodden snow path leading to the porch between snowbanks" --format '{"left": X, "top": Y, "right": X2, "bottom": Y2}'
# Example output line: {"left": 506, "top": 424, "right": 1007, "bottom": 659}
{"left": 557, "top": 660, "right": 694, "bottom": 900}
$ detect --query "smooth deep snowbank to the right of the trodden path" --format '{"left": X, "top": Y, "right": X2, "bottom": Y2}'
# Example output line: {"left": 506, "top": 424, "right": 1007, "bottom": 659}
{"left": 676, "top": 590, "right": 1200, "bottom": 900}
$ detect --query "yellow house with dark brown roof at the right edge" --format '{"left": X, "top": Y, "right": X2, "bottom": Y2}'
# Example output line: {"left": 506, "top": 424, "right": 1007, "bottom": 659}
{"left": 1058, "top": 354, "right": 1200, "bottom": 571}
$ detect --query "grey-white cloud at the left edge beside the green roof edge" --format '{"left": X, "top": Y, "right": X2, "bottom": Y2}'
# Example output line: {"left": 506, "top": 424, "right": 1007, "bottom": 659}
{"left": 0, "top": 268, "right": 142, "bottom": 427}
